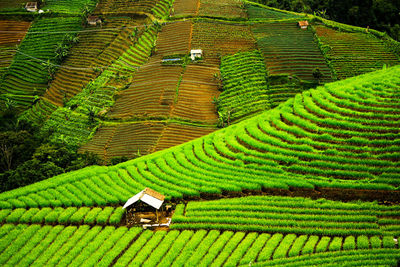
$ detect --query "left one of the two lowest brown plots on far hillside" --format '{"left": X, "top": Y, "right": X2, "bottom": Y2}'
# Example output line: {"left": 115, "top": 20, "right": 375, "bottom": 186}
{"left": 80, "top": 123, "right": 164, "bottom": 161}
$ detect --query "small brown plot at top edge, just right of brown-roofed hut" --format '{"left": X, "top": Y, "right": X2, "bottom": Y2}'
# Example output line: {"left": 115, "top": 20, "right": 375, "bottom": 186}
{"left": 94, "top": 0, "right": 159, "bottom": 15}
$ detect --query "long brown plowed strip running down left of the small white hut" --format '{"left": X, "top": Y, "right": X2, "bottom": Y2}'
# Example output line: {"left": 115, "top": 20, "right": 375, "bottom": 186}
{"left": 110, "top": 22, "right": 191, "bottom": 119}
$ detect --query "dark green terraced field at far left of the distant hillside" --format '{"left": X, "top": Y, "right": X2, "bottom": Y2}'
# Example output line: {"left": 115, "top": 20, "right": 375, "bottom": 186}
{"left": 0, "top": 17, "right": 82, "bottom": 107}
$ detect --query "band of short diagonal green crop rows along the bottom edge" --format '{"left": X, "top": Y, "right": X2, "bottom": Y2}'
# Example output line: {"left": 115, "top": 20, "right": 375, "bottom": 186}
{"left": 0, "top": 224, "right": 397, "bottom": 266}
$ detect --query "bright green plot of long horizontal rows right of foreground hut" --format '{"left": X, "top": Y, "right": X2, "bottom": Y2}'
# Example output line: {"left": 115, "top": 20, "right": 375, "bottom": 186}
{"left": 171, "top": 196, "right": 400, "bottom": 237}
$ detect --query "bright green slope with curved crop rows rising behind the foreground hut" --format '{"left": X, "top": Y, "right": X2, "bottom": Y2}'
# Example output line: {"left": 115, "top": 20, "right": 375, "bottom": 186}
{"left": 0, "top": 64, "right": 400, "bottom": 208}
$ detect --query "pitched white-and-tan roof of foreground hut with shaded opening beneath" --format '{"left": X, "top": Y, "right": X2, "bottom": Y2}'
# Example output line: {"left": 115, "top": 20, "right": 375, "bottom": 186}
{"left": 122, "top": 188, "right": 165, "bottom": 222}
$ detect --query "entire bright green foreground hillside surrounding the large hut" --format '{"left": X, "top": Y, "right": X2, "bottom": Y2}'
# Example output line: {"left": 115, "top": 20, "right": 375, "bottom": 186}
{"left": 0, "top": 67, "right": 400, "bottom": 266}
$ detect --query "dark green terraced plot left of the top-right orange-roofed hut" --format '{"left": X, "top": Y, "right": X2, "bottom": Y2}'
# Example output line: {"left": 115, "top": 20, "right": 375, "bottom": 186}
{"left": 253, "top": 22, "right": 332, "bottom": 82}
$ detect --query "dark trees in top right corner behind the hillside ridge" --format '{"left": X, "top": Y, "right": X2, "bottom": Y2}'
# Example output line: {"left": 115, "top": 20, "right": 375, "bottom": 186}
{"left": 256, "top": 0, "right": 400, "bottom": 41}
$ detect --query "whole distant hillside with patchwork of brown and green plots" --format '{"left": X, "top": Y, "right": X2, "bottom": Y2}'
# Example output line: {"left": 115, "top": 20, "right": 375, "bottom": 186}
{"left": 0, "top": 0, "right": 400, "bottom": 170}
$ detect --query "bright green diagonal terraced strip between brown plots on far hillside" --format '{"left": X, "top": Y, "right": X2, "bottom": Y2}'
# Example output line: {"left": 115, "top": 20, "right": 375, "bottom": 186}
{"left": 38, "top": 24, "right": 161, "bottom": 154}
